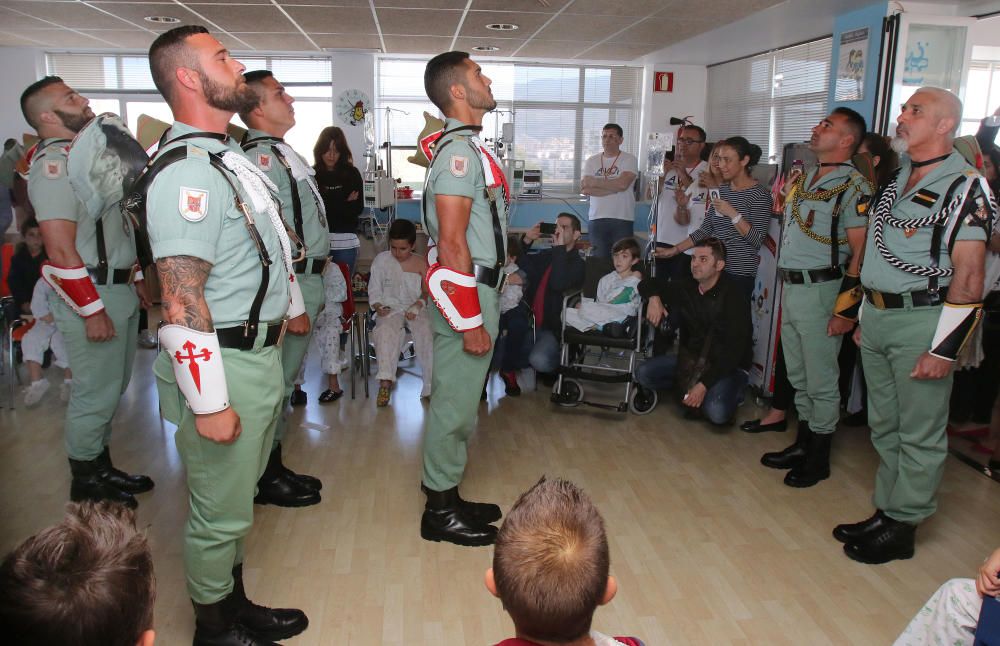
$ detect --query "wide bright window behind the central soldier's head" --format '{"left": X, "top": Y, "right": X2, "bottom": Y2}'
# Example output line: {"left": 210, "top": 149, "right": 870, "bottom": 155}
{"left": 376, "top": 59, "right": 642, "bottom": 193}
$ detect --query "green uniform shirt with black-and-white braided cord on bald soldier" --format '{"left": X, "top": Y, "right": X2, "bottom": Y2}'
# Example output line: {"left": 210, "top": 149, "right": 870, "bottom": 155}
{"left": 861, "top": 152, "right": 989, "bottom": 293}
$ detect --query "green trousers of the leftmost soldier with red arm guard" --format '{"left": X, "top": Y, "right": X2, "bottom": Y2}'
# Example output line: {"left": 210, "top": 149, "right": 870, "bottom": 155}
{"left": 49, "top": 285, "right": 139, "bottom": 461}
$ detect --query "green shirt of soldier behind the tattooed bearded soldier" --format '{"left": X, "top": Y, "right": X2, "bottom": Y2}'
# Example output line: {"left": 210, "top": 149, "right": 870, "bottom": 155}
{"left": 243, "top": 128, "right": 330, "bottom": 258}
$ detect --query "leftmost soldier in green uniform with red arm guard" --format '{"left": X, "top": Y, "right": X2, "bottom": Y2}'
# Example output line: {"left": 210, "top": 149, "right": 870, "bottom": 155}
{"left": 21, "top": 76, "right": 153, "bottom": 507}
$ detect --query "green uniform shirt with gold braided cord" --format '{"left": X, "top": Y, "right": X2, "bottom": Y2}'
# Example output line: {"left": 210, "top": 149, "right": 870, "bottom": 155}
{"left": 778, "top": 165, "right": 872, "bottom": 271}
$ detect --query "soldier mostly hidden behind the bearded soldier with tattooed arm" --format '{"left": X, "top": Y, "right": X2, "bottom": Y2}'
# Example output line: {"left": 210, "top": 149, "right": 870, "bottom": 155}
{"left": 240, "top": 70, "right": 330, "bottom": 507}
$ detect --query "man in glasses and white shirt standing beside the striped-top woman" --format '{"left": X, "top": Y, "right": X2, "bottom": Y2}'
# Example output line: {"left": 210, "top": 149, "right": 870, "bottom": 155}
{"left": 656, "top": 124, "right": 708, "bottom": 279}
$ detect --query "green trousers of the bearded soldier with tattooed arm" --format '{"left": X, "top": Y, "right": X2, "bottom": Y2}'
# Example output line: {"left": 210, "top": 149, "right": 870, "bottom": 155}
{"left": 153, "top": 324, "right": 284, "bottom": 604}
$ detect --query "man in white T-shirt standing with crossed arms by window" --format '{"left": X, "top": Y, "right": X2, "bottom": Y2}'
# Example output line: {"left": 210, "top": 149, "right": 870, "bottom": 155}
{"left": 580, "top": 123, "right": 639, "bottom": 258}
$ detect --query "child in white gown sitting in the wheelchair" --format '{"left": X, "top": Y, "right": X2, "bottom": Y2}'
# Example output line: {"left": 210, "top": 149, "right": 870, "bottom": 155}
{"left": 566, "top": 238, "right": 642, "bottom": 338}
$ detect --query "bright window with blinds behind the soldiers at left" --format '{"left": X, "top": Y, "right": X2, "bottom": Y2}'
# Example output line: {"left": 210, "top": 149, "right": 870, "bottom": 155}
{"left": 45, "top": 52, "right": 333, "bottom": 161}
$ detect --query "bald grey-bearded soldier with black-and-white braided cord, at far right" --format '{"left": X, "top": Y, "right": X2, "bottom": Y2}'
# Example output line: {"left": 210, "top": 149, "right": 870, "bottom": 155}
{"left": 833, "top": 88, "right": 995, "bottom": 563}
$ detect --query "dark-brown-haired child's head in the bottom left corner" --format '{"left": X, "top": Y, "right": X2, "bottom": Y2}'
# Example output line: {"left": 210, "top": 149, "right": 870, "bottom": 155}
{"left": 0, "top": 501, "right": 156, "bottom": 646}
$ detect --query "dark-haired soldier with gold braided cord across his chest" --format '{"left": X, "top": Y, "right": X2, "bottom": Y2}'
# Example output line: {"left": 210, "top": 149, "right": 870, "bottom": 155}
{"left": 761, "top": 108, "right": 874, "bottom": 487}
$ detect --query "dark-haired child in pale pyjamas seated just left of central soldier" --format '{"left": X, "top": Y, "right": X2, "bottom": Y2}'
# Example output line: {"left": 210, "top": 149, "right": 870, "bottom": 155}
{"left": 368, "top": 220, "right": 433, "bottom": 406}
